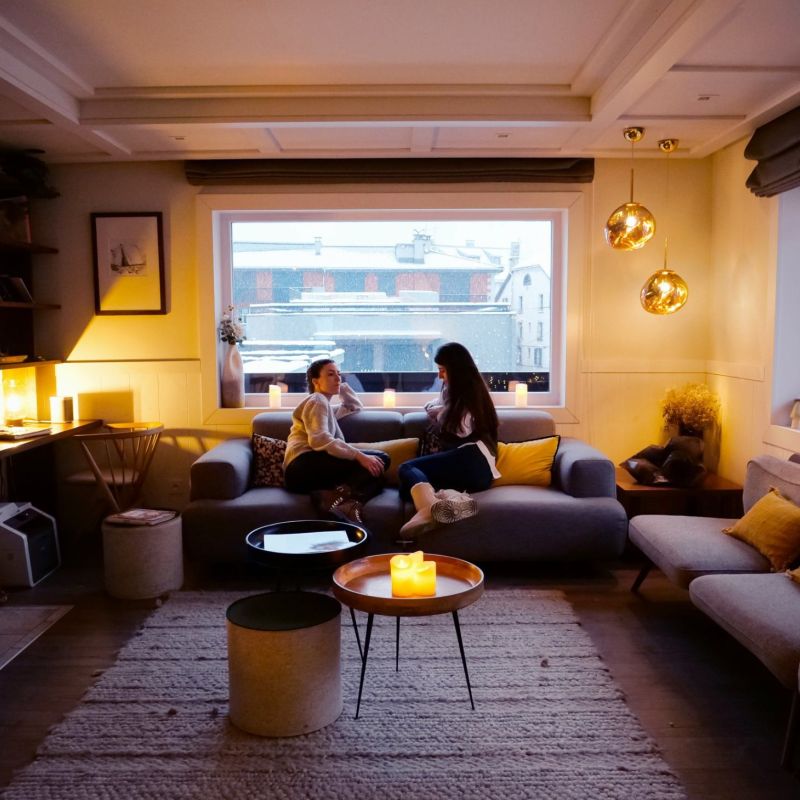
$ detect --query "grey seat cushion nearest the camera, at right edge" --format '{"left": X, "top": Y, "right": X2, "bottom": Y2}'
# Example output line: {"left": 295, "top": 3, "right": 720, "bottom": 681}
{"left": 689, "top": 573, "right": 800, "bottom": 689}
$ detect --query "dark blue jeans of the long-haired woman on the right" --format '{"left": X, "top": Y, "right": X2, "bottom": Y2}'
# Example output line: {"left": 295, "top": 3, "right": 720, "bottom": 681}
{"left": 397, "top": 444, "right": 492, "bottom": 500}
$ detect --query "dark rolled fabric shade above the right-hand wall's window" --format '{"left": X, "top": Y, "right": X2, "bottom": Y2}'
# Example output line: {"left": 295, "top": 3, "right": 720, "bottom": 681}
{"left": 744, "top": 107, "right": 800, "bottom": 197}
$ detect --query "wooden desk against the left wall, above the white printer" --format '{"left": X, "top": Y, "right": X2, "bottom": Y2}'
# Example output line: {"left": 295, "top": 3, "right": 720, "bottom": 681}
{"left": 0, "top": 419, "right": 102, "bottom": 516}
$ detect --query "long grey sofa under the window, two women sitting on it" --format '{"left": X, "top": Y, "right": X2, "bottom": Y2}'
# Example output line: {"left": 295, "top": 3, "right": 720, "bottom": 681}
{"left": 183, "top": 409, "right": 627, "bottom": 563}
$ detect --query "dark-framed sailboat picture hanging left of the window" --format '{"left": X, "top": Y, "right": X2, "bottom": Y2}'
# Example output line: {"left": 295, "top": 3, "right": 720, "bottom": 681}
{"left": 92, "top": 211, "right": 167, "bottom": 314}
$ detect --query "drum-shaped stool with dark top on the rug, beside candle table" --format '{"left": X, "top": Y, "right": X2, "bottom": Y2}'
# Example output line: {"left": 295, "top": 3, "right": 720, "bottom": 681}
{"left": 226, "top": 592, "right": 342, "bottom": 736}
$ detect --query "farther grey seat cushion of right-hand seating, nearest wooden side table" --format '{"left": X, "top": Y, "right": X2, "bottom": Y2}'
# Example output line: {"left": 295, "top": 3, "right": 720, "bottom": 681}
{"left": 628, "top": 514, "right": 770, "bottom": 588}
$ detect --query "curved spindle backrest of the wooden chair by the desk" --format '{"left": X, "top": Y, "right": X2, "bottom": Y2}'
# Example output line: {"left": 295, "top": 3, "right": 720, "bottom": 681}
{"left": 75, "top": 422, "right": 164, "bottom": 513}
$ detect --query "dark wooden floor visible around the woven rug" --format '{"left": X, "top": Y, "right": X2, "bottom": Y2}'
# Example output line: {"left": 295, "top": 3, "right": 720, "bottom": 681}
{"left": 0, "top": 553, "right": 800, "bottom": 800}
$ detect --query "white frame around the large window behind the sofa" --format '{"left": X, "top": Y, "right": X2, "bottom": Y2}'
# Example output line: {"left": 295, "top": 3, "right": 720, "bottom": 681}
{"left": 196, "top": 189, "right": 587, "bottom": 424}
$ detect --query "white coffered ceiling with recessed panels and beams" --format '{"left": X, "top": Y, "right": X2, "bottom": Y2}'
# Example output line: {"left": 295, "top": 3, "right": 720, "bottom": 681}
{"left": 0, "top": 0, "right": 800, "bottom": 162}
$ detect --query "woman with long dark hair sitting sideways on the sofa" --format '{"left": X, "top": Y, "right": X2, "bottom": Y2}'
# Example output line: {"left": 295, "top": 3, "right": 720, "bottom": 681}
{"left": 398, "top": 342, "right": 500, "bottom": 539}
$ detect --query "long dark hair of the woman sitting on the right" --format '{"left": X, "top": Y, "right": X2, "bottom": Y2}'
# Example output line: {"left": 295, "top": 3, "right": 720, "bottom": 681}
{"left": 433, "top": 342, "right": 498, "bottom": 451}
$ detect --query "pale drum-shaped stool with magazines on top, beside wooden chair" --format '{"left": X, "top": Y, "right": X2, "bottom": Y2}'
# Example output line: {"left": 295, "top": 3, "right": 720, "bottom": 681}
{"left": 103, "top": 516, "right": 183, "bottom": 600}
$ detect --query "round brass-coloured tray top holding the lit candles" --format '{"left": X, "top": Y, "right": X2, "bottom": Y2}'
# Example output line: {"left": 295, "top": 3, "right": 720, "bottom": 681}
{"left": 333, "top": 553, "right": 483, "bottom": 617}
